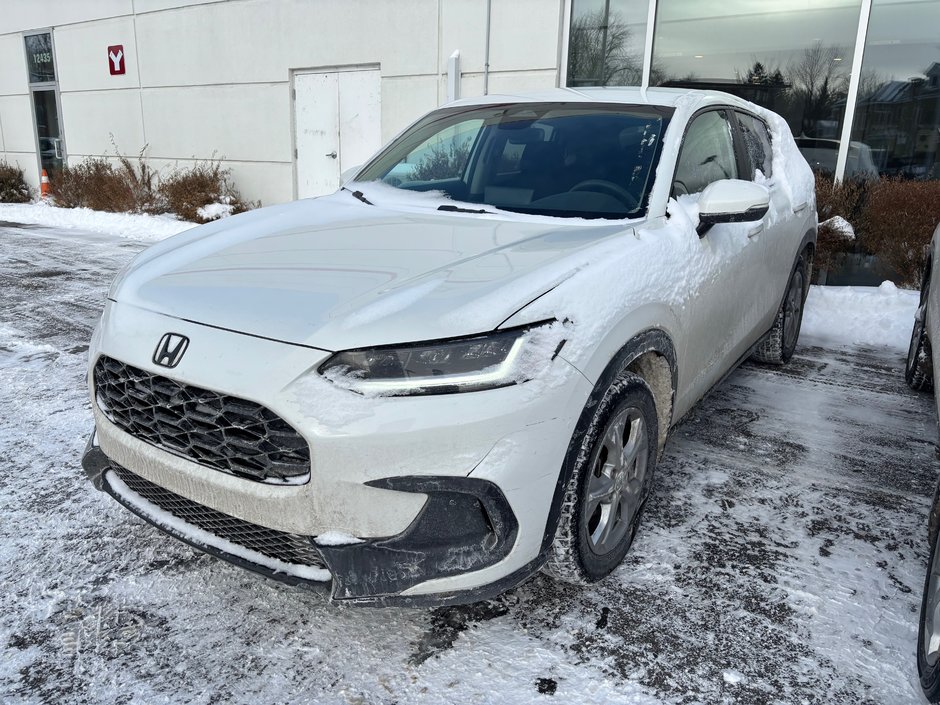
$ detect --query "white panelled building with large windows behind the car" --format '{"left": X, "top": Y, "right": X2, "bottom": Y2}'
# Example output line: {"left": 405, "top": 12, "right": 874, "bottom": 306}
{"left": 0, "top": 0, "right": 940, "bottom": 204}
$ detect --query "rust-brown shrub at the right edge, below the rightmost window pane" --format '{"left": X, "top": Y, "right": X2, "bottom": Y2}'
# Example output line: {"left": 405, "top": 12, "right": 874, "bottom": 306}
{"left": 860, "top": 178, "right": 940, "bottom": 287}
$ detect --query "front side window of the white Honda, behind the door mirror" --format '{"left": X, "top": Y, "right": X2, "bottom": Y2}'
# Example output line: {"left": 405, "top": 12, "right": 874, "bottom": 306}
{"left": 672, "top": 110, "right": 738, "bottom": 196}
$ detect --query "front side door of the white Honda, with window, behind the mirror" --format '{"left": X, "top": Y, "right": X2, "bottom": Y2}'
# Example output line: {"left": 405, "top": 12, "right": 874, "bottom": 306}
{"left": 672, "top": 108, "right": 766, "bottom": 409}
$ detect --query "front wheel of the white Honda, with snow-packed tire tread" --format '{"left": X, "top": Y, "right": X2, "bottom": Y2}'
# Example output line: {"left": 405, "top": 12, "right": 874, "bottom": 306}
{"left": 543, "top": 372, "right": 659, "bottom": 585}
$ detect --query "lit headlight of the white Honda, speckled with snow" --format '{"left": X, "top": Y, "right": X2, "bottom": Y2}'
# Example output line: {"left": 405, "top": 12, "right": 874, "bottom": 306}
{"left": 317, "top": 321, "right": 561, "bottom": 396}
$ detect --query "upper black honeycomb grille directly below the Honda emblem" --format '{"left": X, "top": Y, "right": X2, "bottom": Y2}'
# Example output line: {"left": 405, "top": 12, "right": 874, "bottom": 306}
{"left": 94, "top": 357, "right": 310, "bottom": 483}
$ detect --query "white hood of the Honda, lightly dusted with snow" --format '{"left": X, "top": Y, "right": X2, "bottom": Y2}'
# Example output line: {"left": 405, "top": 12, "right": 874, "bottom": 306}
{"left": 110, "top": 192, "right": 635, "bottom": 350}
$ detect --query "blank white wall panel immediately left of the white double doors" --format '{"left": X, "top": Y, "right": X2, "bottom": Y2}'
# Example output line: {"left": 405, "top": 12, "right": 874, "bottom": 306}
{"left": 140, "top": 82, "right": 293, "bottom": 162}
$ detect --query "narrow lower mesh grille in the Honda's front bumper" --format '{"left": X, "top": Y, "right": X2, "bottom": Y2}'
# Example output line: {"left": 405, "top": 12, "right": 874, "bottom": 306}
{"left": 111, "top": 465, "right": 324, "bottom": 568}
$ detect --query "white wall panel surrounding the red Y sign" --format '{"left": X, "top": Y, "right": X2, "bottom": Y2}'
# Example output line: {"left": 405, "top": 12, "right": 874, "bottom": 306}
{"left": 54, "top": 17, "right": 137, "bottom": 91}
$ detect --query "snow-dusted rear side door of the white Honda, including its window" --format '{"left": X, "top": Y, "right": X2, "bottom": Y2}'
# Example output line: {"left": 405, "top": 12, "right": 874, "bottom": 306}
{"left": 735, "top": 110, "right": 802, "bottom": 342}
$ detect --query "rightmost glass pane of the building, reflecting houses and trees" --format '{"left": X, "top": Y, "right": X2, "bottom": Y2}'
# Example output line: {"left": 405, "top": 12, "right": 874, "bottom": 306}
{"left": 846, "top": 0, "right": 940, "bottom": 179}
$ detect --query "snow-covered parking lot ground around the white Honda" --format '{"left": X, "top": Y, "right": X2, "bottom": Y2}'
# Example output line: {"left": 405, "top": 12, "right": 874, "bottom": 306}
{"left": 0, "top": 217, "right": 938, "bottom": 705}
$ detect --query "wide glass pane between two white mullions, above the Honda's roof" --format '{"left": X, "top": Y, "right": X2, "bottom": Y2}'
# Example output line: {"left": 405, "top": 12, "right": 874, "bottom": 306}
{"left": 650, "top": 0, "right": 859, "bottom": 150}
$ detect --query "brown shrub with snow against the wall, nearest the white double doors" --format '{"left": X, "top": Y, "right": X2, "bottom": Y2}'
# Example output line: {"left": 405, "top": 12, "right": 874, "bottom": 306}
{"left": 159, "top": 160, "right": 258, "bottom": 223}
